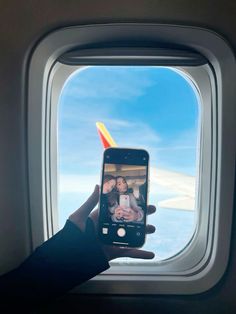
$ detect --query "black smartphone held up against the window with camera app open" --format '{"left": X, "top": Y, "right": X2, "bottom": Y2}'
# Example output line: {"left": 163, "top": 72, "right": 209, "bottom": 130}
{"left": 98, "top": 147, "right": 149, "bottom": 248}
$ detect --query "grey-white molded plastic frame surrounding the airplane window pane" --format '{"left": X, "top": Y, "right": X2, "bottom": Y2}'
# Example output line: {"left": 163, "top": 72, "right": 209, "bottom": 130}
{"left": 28, "top": 23, "right": 236, "bottom": 294}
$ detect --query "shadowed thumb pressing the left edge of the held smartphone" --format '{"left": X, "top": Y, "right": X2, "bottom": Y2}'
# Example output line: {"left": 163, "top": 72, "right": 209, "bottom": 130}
{"left": 69, "top": 185, "right": 99, "bottom": 231}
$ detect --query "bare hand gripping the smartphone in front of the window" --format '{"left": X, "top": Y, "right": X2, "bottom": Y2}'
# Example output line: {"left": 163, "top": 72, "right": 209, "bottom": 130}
{"left": 69, "top": 185, "right": 156, "bottom": 261}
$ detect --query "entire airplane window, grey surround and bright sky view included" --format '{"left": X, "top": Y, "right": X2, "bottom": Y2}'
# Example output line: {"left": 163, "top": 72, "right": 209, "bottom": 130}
{"left": 26, "top": 23, "right": 236, "bottom": 294}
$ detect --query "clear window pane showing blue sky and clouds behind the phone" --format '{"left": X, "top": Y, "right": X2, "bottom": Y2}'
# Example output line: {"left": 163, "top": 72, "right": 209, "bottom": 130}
{"left": 58, "top": 66, "right": 200, "bottom": 260}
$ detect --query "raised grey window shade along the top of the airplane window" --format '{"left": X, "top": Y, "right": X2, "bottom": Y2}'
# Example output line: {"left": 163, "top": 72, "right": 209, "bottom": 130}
{"left": 58, "top": 47, "right": 207, "bottom": 66}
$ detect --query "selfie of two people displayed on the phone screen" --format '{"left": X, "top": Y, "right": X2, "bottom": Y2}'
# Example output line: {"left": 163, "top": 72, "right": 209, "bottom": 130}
{"left": 102, "top": 164, "right": 146, "bottom": 224}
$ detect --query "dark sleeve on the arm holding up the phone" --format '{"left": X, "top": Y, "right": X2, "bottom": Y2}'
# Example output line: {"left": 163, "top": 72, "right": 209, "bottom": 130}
{"left": 0, "top": 219, "right": 109, "bottom": 312}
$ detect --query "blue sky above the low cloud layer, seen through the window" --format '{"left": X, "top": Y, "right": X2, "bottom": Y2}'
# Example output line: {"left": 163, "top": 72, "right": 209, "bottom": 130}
{"left": 59, "top": 66, "right": 199, "bottom": 175}
